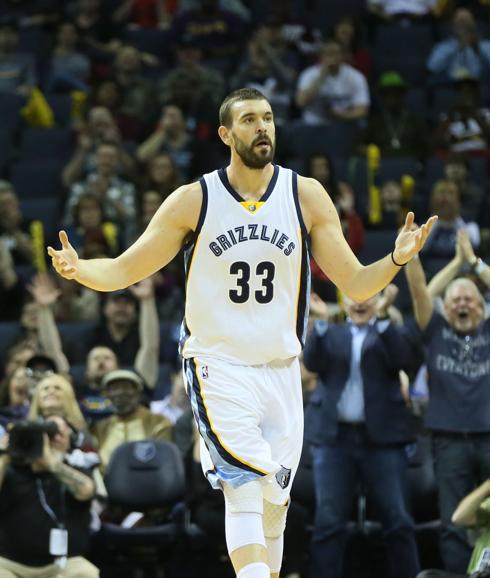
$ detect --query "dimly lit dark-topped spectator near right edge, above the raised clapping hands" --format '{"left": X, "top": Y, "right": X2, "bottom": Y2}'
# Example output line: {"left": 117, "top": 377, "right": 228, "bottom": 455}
{"left": 444, "top": 153, "right": 485, "bottom": 222}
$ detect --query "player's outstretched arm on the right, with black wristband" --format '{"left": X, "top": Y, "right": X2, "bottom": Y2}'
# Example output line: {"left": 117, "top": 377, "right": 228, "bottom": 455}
{"left": 298, "top": 177, "right": 437, "bottom": 302}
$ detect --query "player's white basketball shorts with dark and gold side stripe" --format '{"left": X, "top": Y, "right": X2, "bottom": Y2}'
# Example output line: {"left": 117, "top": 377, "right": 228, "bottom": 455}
{"left": 184, "top": 357, "right": 303, "bottom": 504}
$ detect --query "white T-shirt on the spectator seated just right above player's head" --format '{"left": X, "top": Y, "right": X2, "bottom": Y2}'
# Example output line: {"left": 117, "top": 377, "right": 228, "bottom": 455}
{"left": 298, "top": 64, "right": 370, "bottom": 124}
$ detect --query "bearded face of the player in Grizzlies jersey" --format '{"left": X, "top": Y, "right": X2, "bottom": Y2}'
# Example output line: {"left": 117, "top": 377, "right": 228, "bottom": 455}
{"left": 231, "top": 100, "right": 276, "bottom": 169}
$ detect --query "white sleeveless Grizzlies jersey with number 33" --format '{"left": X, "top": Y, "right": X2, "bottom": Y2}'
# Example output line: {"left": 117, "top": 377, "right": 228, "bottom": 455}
{"left": 181, "top": 165, "right": 310, "bottom": 365}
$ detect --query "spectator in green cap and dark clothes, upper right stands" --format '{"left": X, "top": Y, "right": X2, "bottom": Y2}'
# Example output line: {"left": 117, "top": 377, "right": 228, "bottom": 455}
{"left": 360, "top": 72, "right": 428, "bottom": 159}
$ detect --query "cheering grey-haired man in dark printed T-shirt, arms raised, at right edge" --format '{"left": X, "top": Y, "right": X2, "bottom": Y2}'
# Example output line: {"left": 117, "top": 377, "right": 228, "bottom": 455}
{"left": 406, "top": 259, "right": 490, "bottom": 574}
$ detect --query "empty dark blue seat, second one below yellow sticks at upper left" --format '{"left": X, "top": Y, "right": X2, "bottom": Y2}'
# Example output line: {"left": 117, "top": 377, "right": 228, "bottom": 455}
{"left": 10, "top": 160, "right": 64, "bottom": 199}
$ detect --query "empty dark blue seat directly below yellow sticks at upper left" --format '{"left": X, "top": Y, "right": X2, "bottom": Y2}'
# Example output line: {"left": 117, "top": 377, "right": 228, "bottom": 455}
{"left": 19, "top": 128, "right": 72, "bottom": 162}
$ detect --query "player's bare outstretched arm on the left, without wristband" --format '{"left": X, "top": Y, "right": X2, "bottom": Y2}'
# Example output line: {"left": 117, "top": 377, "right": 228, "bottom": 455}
{"left": 48, "top": 183, "right": 202, "bottom": 291}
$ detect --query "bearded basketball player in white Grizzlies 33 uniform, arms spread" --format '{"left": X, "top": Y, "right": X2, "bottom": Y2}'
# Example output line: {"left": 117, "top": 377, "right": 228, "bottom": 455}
{"left": 48, "top": 88, "right": 436, "bottom": 578}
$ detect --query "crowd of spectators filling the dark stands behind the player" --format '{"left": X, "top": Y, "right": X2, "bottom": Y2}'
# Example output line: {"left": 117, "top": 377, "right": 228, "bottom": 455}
{"left": 0, "top": 0, "right": 490, "bottom": 578}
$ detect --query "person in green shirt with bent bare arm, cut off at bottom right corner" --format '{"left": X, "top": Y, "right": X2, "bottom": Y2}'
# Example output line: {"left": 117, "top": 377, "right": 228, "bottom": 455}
{"left": 417, "top": 479, "right": 490, "bottom": 578}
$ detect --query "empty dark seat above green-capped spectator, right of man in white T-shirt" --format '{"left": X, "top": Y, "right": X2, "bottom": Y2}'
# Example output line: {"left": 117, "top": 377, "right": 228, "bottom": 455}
{"left": 373, "top": 24, "right": 434, "bottom": 86}
